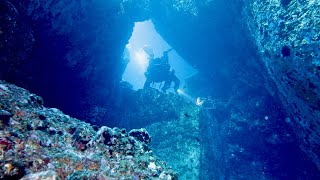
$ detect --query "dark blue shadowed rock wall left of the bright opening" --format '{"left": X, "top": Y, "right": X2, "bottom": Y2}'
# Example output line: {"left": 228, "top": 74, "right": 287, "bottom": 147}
{"left": 0, "top": 0, "right": 148, "bottom": 120}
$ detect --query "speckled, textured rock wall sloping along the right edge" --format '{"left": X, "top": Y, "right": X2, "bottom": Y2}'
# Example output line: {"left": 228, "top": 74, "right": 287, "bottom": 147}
{"left": 244, "top": 0, "right": 320, "bottom": 169}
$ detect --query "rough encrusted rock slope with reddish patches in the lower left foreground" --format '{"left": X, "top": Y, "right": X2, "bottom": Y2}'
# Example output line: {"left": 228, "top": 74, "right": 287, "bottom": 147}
{"left": 0, "top": 81, "right": 177, "bottom": 179}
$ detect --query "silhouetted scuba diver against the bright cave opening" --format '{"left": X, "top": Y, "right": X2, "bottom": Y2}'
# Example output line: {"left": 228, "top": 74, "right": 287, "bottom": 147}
{"left": 143, "top": 46, "right": 180, "bottom": 93}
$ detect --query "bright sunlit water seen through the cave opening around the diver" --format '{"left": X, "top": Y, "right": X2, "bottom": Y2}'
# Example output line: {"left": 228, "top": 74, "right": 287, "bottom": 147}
{"left": 122, "top": 20, "right": 197, "bottom": 90}
